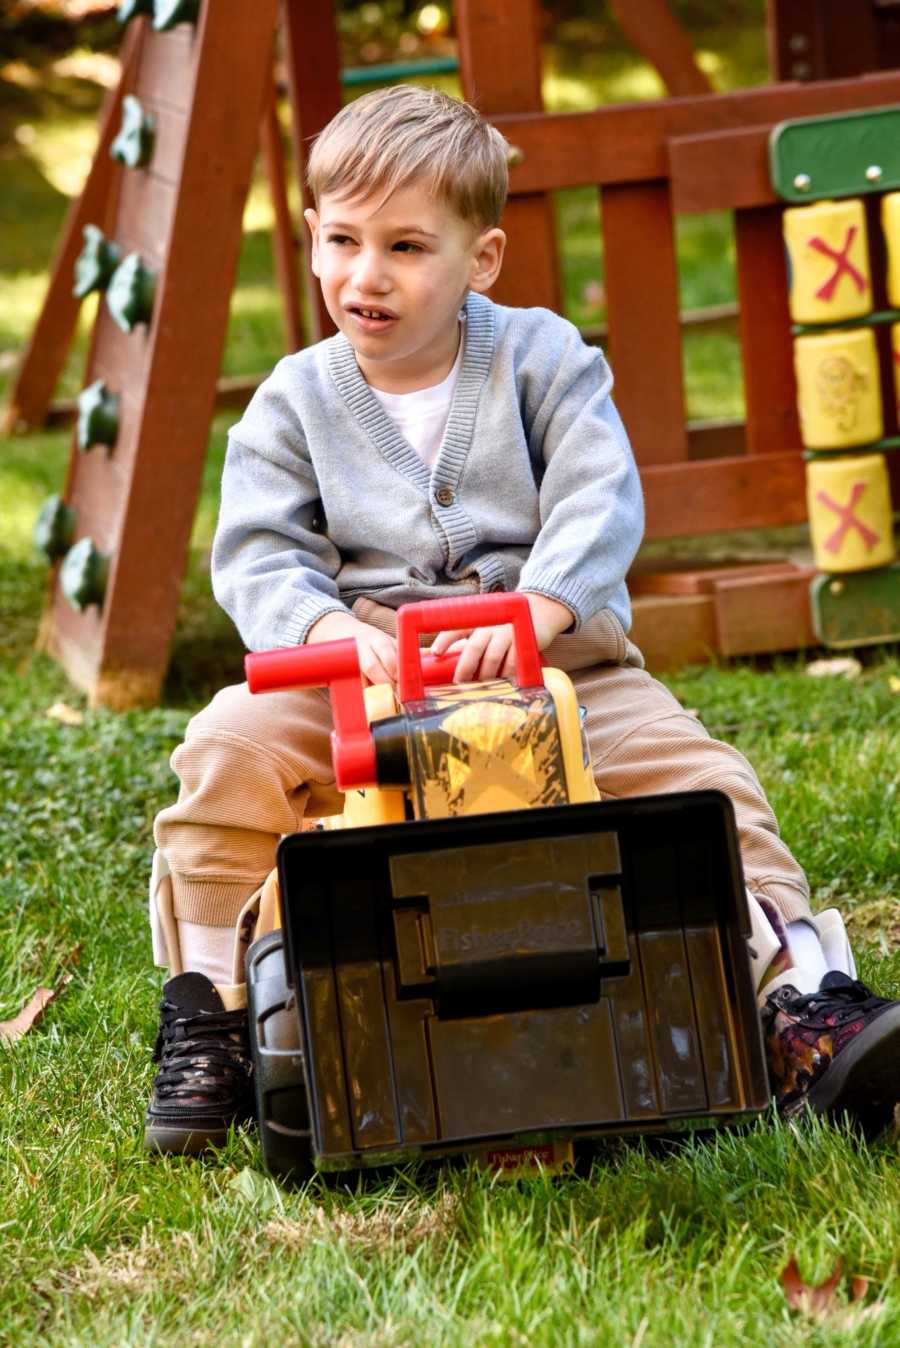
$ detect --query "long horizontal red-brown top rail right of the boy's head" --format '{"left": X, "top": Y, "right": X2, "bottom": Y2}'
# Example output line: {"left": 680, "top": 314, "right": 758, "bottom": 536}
{"left": 492, "top": 71, "right": 900, "bottom": 194}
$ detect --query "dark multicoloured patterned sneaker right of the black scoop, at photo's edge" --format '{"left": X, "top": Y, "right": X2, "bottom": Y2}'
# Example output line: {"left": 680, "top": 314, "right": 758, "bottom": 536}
{"left": 763, "top": 971, "right": 900, "bottom": 1136}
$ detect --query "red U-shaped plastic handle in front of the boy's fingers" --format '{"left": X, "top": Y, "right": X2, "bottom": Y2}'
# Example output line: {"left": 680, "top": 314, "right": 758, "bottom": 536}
{"left": 397, "top": 593, "right": 544, "bottom": 702}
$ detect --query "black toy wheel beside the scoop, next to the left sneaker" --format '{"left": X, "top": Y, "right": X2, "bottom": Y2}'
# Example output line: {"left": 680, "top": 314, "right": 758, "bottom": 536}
{"left": 247, "top": 930, "right": 314, "bottom": 1184}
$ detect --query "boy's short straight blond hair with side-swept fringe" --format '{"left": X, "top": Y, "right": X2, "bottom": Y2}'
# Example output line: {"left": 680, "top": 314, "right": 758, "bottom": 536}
{"left": 307, "top": 85, "right": 509, "bottom": 229}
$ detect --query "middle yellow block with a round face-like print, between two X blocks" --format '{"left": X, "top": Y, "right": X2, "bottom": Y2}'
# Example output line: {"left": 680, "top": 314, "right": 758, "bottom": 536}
{"left": 794, "top": 328, "right": 884, "bottom": 449}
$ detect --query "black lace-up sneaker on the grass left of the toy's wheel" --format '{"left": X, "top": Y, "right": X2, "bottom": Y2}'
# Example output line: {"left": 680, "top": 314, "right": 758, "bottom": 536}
{"left": 144, "top": 973, "right": 252, "bottom": 1155}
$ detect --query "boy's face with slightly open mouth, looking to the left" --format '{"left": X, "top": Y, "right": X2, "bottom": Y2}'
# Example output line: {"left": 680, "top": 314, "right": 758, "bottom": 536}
{"left": 304, "top": 183, "right": 505, "bottom": 394}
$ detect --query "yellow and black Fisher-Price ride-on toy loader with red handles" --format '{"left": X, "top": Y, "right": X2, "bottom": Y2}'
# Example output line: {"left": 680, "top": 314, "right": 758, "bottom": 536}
{"left": 247, "top": 594, "right": 769, "bottom": 1178}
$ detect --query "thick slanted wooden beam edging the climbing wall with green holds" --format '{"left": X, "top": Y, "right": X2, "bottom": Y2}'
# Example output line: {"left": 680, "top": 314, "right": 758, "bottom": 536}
{"left": 44, "top": 0, "right": 278, "bottom": 708}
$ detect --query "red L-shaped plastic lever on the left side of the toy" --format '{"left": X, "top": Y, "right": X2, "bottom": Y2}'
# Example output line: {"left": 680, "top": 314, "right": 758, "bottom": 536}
{"left": 244, "top": 639, "right": 377, "bottom": 791}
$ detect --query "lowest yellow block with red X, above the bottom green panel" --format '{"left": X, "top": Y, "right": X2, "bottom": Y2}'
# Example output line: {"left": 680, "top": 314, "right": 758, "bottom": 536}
{"left": 806, "top": 454, "right": 893, "bottom": 572}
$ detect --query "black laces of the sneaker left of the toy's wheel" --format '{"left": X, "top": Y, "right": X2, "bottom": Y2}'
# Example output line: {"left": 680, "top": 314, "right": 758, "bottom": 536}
{"left": 154, "top": 1002, "right": 249, "bottom": 1099}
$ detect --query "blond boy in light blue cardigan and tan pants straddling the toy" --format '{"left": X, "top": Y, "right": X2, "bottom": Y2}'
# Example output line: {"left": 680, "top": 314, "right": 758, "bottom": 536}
{"left": 146, "top": 86, "right": 900, "bottom": 1151}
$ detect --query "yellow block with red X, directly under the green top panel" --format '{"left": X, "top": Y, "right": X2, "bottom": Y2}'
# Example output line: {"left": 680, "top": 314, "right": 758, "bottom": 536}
{"left": 784, "top": 197, "right": 872, "bottom": 324}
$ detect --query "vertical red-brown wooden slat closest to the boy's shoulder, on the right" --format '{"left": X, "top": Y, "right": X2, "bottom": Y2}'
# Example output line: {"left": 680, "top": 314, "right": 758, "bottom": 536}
{"left": 601, "top": 182, "right": 687, "bottom": 466}
